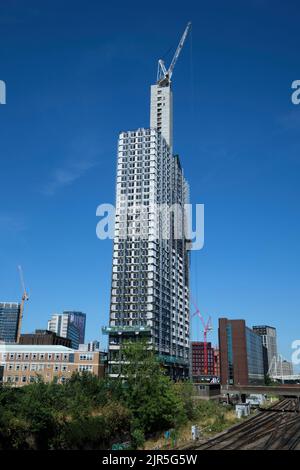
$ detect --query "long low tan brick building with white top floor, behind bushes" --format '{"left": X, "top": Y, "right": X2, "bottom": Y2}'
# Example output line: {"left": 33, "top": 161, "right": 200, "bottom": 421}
{"left": 0, "top": 344, "right": 105, "bottom": 387}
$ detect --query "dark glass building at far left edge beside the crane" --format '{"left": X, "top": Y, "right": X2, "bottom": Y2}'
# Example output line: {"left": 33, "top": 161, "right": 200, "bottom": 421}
{"left": 0, "top": 302, "right": 20, "bottom": 343}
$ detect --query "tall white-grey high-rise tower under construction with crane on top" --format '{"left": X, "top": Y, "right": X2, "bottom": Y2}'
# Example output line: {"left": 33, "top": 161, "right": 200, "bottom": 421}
{"left": 104, "top": 24, "right": 190, "bottom": 377}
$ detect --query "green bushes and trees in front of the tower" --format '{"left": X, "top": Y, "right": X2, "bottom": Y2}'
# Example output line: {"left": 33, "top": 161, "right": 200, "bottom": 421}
{"left": 0, "top": 342, "right": 234, "bottom": 450}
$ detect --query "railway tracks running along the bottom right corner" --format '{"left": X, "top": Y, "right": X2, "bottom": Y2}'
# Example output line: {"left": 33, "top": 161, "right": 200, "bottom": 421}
{"left": 186, "top": 398, "right": 300, "bottom": 450}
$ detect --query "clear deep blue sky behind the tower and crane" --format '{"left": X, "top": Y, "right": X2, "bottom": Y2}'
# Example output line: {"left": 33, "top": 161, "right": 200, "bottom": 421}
{"left": 0, "top": 0, "right": 300, "bottom": 364}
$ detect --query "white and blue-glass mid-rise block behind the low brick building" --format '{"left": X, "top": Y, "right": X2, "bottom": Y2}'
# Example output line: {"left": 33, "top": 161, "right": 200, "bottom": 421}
{"left": 48, "top": 311, "right": 86, "bottom": 349}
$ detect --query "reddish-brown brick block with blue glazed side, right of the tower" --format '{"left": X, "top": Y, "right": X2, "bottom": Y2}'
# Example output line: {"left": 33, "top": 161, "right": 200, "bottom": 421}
{"left": 219, "top": 318, "right": 265, "bottom": 385}
